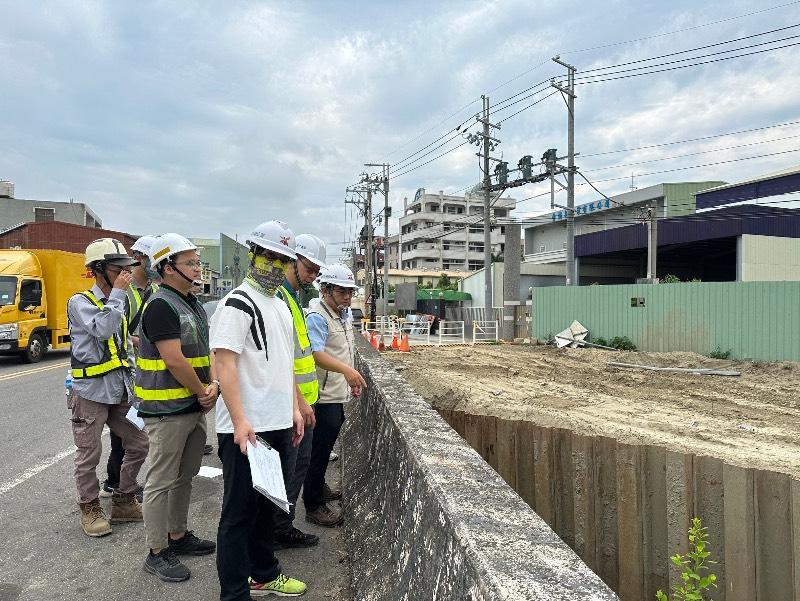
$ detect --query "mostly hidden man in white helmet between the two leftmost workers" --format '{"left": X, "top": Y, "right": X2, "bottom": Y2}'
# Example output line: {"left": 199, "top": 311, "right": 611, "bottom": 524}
{"left": 100, "top": 236, "right": 161, "bottom": 503}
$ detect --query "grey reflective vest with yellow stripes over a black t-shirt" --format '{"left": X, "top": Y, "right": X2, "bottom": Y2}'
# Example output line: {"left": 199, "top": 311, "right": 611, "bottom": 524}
{"left": 133, "top": 286, "right": 211, "bottom": 415}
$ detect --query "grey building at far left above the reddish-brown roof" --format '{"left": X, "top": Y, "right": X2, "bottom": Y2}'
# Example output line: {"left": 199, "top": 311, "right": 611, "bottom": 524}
{"left": 0, "top": 181, "right": 103, "bottom": 231}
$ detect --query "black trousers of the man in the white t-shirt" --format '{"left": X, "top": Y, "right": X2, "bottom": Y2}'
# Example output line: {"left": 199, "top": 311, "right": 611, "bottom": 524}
{"left": 217, "top": 428, "right": 292, "bottom": 601}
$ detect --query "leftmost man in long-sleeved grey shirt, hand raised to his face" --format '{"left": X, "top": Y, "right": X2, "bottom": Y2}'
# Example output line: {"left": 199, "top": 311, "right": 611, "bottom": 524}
{"left": 67, "top": 238, "right": 148, "bottom": 536}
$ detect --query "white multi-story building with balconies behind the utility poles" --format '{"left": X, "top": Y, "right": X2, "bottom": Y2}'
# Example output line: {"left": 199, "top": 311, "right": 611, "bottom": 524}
{"left": 396, "top": 188, "right": 516, "bottom": 271}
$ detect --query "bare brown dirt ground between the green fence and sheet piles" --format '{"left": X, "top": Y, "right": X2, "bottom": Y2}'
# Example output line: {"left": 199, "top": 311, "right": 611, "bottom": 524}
{"left": 385, "top": 345, "right": 800, "bottom": 477}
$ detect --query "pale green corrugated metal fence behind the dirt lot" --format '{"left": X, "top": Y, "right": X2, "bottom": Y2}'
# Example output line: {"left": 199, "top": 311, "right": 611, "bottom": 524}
{"left": 533, "top": 282, "right": 800, "bottom": 361}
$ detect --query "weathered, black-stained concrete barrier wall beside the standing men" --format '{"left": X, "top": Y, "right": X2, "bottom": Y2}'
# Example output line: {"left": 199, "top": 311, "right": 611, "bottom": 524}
{"left": 342, "top": 338, "right": 617, "bottom": 601}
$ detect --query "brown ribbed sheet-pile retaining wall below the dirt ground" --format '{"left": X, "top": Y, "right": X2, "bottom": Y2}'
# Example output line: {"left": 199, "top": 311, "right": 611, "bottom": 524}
{"left": 434, "top": 411, "right": 800, "bottom": 601}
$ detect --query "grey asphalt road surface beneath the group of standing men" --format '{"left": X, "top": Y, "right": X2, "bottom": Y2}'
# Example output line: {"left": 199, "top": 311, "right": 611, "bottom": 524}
{"left": 0, "top": 352, "right": 349, "bottom": 601}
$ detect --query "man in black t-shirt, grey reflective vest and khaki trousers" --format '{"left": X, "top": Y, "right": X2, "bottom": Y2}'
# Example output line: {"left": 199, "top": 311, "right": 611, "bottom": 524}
{"left": 136, "top": 234, "right": 219, "bottom": 582}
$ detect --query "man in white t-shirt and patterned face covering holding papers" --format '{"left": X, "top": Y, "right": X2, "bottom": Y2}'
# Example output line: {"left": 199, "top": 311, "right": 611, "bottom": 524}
{"left": 211, "top": 221, "right": 306, "bottom": 601}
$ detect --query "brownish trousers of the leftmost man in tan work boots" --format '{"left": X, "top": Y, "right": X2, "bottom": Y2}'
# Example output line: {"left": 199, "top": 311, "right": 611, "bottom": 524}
{"left": 67, "top": 392, "right": 147, "bottom": 503}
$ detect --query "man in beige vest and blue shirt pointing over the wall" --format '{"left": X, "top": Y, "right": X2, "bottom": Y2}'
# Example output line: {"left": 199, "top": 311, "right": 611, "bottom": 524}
{"left": 303, "top": 264, "right": 366, "bottom": 527}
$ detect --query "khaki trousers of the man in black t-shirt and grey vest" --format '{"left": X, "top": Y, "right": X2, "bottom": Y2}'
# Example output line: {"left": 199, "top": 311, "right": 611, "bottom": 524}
{"left": 142, "top": 411, "right": 206, "bottom": 549}
